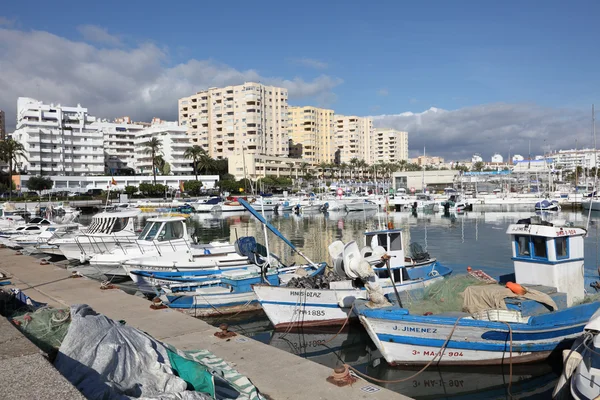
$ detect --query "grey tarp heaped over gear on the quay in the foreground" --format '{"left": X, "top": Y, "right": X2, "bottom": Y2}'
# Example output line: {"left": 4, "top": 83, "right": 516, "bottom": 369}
{"left": 54, "top": 305, "right": 211, "bottom": 400}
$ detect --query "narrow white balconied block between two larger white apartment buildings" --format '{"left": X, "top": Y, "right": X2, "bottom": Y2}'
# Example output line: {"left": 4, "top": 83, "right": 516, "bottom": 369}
{"left": 93, "top": 117, "right": 149, "bottom": 175}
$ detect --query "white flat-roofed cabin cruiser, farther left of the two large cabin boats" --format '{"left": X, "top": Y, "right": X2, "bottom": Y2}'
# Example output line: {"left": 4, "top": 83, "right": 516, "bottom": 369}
{"left": 48, "top": 208, "right": 141, "bottom": 263}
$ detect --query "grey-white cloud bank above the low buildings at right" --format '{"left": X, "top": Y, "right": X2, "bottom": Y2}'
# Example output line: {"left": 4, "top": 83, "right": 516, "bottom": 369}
{"left": 373, "top": 103, "right": 593, "bottom": 161}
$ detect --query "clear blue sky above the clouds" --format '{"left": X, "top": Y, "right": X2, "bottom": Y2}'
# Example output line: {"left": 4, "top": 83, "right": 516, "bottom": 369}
{"left": 0, "top": 1, "right": 600, "bottom": 159}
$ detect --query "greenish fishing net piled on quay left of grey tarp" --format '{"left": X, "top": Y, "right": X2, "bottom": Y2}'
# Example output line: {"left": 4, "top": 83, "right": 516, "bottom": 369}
{"left": 12, "top": 307, "right": 71, "bottom": 353}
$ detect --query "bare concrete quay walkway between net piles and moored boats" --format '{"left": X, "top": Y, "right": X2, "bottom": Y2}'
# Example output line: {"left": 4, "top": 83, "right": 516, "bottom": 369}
{"left": 0, "top": 249, "right": 409, "bottom": 400}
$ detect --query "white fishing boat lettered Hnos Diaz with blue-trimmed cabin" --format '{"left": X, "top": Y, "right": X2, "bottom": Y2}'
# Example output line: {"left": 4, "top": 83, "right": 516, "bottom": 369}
{"left": 254, "top": 229, "right": 452, "bottom": 329}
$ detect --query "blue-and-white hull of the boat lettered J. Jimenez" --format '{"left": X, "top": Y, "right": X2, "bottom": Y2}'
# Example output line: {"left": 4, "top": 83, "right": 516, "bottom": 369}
{"left": 358, "top": 302, "right": 600, "bottom": 365}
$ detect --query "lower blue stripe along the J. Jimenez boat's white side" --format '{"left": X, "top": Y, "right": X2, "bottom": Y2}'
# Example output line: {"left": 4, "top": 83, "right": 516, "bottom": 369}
{"left": 377, "top": 326, "right": 583, "bottom": 352}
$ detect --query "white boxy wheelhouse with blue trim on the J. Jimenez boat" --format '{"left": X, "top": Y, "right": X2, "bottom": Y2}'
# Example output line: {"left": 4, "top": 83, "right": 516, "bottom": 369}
{"left": 506, "top": 217, "right": 586, "bottom": 307}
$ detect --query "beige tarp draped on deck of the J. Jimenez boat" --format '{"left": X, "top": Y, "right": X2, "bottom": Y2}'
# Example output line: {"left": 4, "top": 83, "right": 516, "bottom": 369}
{"left": 462, "top": 285, "right": 558, "bottom": 314}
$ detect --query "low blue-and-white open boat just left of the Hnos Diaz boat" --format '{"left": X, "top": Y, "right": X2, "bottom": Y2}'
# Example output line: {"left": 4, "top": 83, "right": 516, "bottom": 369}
{"left": 160, "top": 263, "right": 327, "bottom": 317}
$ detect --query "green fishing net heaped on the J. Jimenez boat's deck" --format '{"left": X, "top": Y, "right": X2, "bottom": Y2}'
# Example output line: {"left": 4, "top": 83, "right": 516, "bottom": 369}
{"left": 402, "top": 275, "right": 487, "bottom": 315}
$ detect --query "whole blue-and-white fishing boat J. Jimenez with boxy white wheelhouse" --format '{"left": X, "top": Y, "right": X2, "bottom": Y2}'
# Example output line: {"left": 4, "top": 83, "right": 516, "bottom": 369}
{"left": 355, "top": 218, "right": 600, "bottom": 365}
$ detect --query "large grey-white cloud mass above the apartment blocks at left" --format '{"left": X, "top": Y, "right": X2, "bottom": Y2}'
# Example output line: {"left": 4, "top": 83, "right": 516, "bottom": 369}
{"left": 0, "top": 28, "right": 342, "bottom": 128}
